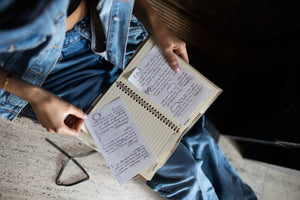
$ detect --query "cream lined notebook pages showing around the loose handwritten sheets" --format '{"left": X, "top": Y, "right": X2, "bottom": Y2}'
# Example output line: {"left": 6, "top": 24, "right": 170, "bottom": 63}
{"left": 81, "top": 38, "right": 222, "bottom": 180}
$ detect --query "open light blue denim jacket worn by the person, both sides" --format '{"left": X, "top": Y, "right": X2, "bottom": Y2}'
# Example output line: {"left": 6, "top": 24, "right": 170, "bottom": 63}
{"left": 0, "top": 0, "right": 134, "bottom": 120}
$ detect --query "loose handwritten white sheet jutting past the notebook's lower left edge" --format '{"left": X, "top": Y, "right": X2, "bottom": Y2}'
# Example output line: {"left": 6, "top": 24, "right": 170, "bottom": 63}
{"left": 85, "top": 98, "right": 156, "bottom": 185}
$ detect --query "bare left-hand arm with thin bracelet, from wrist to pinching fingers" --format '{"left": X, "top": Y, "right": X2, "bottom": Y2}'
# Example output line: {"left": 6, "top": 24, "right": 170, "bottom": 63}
{"left": 0, "top": 68, "right": 86, "bottom": 136}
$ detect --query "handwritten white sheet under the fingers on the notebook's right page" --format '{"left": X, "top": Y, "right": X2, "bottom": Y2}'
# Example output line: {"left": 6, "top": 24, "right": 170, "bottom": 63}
{"left": 128, "top": 46, "right": 211, "bottom": 124}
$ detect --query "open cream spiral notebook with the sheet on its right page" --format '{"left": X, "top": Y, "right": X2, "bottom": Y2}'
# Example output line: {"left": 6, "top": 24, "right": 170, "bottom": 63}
{"left": 80, "top": 38, "right": 222, "bottom": 180}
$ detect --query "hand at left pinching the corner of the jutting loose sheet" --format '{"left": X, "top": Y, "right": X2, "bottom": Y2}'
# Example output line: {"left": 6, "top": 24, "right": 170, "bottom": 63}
{"left": 29, "top": 88, "right": 86, "bottom": 136}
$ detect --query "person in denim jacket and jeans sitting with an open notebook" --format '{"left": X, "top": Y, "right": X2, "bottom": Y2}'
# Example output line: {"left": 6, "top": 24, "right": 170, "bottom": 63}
{"left": 0, "top": 0, "right": 257, "bottom": 200}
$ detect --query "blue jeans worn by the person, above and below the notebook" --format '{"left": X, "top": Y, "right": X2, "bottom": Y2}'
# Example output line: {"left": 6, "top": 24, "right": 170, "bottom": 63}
{"left": 24, "top": 17, "right": 256, "bottom": 200}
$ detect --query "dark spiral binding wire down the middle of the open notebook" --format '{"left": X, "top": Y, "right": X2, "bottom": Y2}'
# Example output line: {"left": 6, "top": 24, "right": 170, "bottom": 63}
{"left": 116, "top": 81, "right": 180, "bottom": 133}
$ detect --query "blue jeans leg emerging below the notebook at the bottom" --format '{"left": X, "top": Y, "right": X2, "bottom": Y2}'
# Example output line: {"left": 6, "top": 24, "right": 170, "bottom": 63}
{"left": 147, "top": 116, "right": 257, "bottom": 200}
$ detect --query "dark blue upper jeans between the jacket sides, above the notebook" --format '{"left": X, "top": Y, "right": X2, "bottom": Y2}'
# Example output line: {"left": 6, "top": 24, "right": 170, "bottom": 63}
{"left": 22, "top": 17, "right": 147, "bottom": 115}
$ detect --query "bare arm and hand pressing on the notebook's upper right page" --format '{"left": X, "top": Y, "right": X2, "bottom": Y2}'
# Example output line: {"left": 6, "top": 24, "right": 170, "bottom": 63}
{"left": 133, "top": 0, "right": 189, "bottom": 71}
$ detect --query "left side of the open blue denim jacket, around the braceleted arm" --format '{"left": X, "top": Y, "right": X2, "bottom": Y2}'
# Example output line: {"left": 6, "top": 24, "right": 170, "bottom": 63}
{"left": 0, "top": 0, "right": 68, "bottom": 120}
